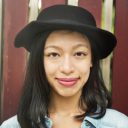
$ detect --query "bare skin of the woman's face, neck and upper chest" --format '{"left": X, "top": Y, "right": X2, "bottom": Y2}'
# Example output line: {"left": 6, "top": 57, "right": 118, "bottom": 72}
{"left": 44, "top": 30, "right": 92, "bottom": 128}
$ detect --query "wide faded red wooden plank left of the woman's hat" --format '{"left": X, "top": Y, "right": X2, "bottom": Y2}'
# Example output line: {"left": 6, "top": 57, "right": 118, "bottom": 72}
{"left": 1, "top": 0, "right": 28, "bottom": 120}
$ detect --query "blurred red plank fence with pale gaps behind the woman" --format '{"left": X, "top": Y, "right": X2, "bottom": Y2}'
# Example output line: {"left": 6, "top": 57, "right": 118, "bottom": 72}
{"left": 0, "top": 0, "right": 128, "bottom": 122}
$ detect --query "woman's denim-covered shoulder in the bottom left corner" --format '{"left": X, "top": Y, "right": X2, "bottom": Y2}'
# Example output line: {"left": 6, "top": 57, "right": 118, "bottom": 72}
{"left": 0, "top": 116, "right": 20, "bottom": 128}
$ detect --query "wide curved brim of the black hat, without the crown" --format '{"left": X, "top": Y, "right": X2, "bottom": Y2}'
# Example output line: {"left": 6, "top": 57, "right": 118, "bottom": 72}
{"left": 15, "top": 21, "right": 117, "bottom": 59}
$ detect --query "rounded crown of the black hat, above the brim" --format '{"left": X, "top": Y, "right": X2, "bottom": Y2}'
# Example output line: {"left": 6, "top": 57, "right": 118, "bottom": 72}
{"left": 37, "top": 5, "right": 96, "bottom": 26}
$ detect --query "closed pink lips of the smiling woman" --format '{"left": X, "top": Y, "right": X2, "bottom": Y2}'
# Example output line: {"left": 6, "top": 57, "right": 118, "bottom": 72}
{"left": 57, "top": 78, "right": 79, "bottom": 87}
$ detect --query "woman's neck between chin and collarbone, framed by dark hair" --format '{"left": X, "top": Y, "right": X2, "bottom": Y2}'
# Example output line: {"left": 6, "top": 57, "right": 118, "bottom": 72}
{"left": 49, "top": 93, "right": 81, "bottom": 116}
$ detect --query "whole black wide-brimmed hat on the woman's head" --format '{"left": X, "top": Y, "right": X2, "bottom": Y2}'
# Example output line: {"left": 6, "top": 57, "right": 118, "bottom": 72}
{"left": 15, "top": 5, "right": 117, "bottom": 59}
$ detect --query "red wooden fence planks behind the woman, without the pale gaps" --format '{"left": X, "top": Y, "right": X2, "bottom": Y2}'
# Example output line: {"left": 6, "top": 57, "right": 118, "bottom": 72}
{"left": 0, "top": 0, "right": 128, "bottom": 121}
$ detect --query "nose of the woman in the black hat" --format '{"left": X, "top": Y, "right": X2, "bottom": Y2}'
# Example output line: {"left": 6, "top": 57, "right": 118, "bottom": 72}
{"left": 60, "top": 56, "right": 74, "bottom": 75}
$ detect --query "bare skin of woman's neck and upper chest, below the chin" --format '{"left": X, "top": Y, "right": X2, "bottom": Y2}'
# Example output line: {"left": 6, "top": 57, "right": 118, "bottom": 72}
{"left": 49, "top": 88, "right": 84, "bottom": 128}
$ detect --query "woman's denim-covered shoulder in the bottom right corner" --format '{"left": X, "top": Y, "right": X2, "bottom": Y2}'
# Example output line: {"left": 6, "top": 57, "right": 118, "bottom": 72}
{"left": 101, "top": 109, "right": 128, "bottom": 128}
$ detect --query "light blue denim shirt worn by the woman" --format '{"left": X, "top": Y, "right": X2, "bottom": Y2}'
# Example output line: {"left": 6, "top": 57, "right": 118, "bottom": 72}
{"left": 0, "top": 109, "right": 128, "bottom": 128}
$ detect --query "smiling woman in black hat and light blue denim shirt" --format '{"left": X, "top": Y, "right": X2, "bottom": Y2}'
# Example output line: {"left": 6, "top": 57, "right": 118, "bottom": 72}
{"left": 1, "top": 5, "right": 128, "bottom": 128}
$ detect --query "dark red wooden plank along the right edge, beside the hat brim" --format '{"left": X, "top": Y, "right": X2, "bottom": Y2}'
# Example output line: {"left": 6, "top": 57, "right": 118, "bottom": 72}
{"left": 112, "top": 0, "right": 128, "bottom": 115}
